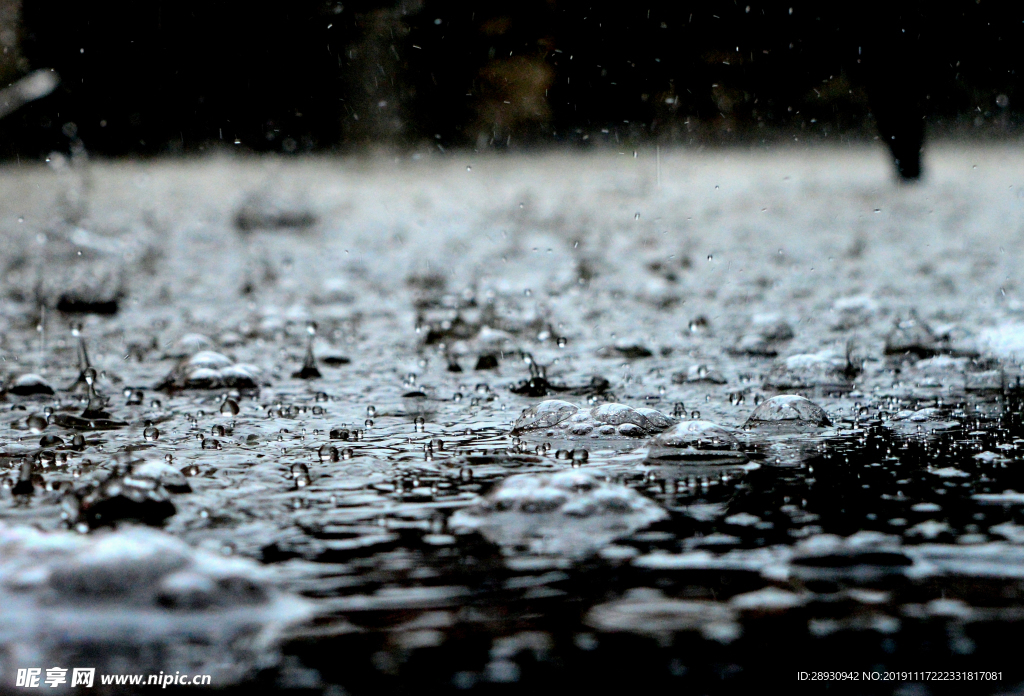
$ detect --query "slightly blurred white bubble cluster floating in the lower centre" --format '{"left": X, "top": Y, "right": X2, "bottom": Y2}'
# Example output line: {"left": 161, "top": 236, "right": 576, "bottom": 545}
{"left": 449, "top": 471, "right": 669, "bottom": 557}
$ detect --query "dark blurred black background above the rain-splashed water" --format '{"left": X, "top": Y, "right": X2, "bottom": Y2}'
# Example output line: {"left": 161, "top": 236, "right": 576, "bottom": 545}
{"left": 0, "top": 0, "right": 1024, "bottom": 158}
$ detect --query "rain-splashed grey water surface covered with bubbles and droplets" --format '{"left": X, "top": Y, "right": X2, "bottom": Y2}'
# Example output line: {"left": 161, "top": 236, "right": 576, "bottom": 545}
{"left": 0, "top": 146, "right": 1024, "bottom": 696}
